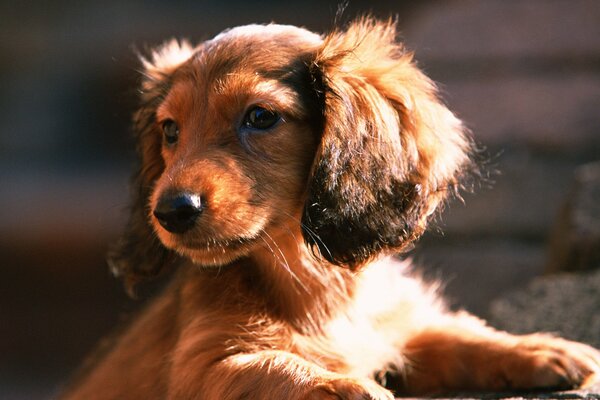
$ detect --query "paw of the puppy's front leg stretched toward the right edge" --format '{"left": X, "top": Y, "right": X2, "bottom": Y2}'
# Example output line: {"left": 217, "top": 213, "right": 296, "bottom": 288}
{"left": 503, "top": 335, "right": 600, "bottom": 389}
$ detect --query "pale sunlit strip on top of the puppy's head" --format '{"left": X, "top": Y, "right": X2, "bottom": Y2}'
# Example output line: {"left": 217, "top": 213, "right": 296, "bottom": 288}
{"left": 211, "top": 24, "right": 323, "bottom": 46}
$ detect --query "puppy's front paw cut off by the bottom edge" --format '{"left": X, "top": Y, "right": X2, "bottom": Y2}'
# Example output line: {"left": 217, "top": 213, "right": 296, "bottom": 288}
{"left": 304, "top": 378, "right": 394, "bottom": 400}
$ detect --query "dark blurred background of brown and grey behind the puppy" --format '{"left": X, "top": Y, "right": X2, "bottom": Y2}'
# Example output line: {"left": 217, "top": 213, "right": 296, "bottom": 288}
{"left": 0, "top": 0, "right": 600, "bottom": 399}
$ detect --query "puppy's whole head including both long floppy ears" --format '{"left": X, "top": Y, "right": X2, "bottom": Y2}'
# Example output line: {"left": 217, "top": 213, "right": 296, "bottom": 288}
{"left": 112, "top": 19, "right": 470, "bottom": 288}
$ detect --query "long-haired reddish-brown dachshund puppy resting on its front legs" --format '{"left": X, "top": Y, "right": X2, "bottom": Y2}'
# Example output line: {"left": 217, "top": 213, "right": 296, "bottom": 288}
{"left": 64, "top": 18, "right": 600, "bottom": 400}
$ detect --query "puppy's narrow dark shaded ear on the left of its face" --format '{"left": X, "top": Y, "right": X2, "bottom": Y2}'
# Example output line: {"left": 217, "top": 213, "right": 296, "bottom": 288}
{"left": 108, "top": 40, "right": 193, "bottom": 291}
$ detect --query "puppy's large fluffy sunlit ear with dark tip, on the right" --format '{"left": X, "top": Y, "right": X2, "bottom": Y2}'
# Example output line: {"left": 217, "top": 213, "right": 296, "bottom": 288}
{"left": 302, "top": 18, "right": 471, "bottom": 268}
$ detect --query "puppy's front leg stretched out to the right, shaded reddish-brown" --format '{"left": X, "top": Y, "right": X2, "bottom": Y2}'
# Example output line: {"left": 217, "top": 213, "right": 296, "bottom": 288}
{"left": 403, "top": 313, "right": 600, "bottom": 394}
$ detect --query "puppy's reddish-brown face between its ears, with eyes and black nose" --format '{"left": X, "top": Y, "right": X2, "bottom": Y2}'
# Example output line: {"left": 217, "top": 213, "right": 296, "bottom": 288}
{"left": 148, "top": 26, "right": 320, "bottom": 265}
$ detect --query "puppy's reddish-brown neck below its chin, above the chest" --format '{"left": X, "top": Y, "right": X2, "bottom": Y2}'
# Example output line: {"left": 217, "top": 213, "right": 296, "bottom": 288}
{"left": 180, "top": 230, "right": 356, "bottom": 334}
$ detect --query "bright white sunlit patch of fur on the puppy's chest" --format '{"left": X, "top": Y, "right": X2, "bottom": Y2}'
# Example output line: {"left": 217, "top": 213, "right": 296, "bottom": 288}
{"left": 304, "top": 259, "right": 439, "bottom": 376}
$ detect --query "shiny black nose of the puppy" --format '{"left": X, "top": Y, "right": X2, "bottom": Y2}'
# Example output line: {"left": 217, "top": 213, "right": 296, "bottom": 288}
{"left": 154, "top": 193, "right": 204, "bottom": 233}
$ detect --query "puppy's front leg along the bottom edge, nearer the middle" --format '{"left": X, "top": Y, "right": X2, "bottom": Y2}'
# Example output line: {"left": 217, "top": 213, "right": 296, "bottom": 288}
{"left": 168, "top": 350, "right": 393, "bottom": 400}
